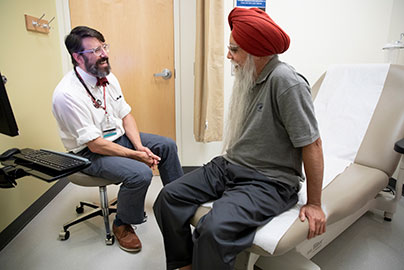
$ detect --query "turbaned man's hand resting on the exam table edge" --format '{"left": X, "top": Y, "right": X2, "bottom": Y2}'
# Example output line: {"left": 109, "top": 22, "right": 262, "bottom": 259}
{"left": 299, "top": 204, "right": 326, "bottom": 239}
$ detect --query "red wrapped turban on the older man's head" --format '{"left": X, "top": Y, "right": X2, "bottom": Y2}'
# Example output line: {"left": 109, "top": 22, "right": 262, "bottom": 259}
{"left": 229, "top": 7, "right": 290, "bottom": 56}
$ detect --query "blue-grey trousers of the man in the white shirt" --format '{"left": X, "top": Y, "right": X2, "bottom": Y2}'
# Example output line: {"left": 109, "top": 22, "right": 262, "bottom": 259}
{"left": 78, "top": 133, "right": 184, "bottom": 224}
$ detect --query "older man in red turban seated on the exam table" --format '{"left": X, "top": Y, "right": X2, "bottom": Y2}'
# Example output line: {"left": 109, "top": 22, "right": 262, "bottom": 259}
{"left": 154, "top": 8, "right": 325, "bottom": 270}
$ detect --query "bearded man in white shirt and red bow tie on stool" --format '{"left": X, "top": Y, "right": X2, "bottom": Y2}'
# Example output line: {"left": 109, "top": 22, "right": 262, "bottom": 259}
{"left": 53, "top": 26, "right": 183, "bottom": 252}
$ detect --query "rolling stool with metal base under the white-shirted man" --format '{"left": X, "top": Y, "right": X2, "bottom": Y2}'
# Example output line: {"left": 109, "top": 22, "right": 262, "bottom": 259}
{"left": 59, "top": 172, "right": 119, "bottom": 245}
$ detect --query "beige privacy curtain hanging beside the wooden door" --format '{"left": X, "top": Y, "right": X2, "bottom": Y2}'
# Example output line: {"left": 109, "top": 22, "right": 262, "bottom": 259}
{"left": 194, "top": 0, "right": 224, "bottom": 142}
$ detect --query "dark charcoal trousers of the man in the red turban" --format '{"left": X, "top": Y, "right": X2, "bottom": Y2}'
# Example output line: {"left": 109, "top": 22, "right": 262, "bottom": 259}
{"left": 153, "top": 157, "right": 297, "bottom": 270}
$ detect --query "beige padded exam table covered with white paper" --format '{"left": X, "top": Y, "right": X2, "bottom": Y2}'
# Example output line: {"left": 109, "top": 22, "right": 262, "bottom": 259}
{"left": 191, "top": 64, "right": 404, "bottom": 270}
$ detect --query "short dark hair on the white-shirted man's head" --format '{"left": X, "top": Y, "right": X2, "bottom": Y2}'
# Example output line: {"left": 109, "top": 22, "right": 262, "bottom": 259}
{"left": 65, "top": 26, "right": 105, "bottom": 66}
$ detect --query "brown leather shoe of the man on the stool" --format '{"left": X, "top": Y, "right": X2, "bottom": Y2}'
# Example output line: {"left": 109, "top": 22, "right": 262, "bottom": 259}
{"left": 112, "top": 224, "right": 142, "bottom": 252}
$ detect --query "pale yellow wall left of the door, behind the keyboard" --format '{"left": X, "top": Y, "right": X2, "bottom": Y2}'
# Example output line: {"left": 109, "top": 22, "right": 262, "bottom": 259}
{"left": 0, "top": 0, "right": 63, "bottom": 231}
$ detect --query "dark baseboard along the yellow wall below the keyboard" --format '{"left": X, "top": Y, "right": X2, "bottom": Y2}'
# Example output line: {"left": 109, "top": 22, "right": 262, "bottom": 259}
{"left": 0, "top": 178, "right": 69, "bottom": 251}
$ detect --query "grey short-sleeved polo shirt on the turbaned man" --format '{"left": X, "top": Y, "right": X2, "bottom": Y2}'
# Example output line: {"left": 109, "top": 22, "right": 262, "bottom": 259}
{"left": 224, "top": 55, "right": 320, "bottom": 187}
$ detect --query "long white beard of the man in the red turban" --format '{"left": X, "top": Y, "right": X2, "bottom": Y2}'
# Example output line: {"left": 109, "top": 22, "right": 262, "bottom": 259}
{"left": 223, "top": 55, "right": 256, "bottom": 151}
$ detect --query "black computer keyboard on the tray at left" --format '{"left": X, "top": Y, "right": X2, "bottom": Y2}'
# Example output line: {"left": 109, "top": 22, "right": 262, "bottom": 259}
{"left": 13, "top": 148, "right": 90, "bottom": 172}
